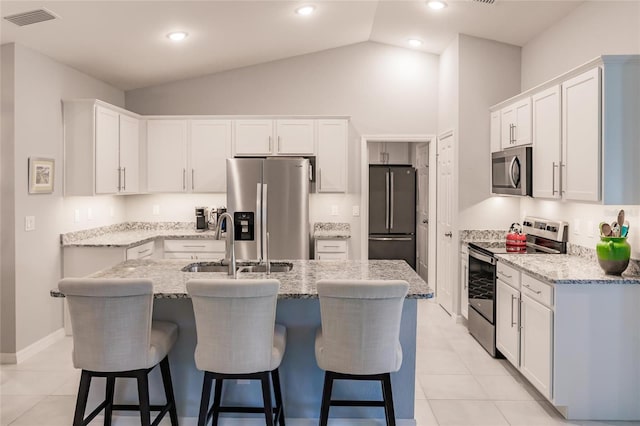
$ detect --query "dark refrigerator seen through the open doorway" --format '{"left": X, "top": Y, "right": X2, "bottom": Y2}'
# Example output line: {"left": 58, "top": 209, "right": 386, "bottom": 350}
{"left": 369, "top": 166, "right": 416, "bottom": 269}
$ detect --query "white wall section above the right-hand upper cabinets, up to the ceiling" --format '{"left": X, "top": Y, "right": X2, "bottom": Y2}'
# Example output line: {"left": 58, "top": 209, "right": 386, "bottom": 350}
{"left": 521, "top": 1, "right": 640, "bottom": 90}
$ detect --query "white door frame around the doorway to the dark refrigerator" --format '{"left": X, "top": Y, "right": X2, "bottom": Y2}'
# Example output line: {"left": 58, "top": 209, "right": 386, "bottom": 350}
{"left": 360, "top": 134, "right": 436, "bottom": 283}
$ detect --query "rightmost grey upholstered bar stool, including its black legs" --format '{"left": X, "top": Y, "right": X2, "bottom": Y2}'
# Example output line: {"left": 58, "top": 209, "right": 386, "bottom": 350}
{"left": 315, "top": 280, "right": 409, "bottom": 426}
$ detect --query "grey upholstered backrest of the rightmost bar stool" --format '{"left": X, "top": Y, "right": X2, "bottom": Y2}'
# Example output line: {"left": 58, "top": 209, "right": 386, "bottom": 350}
{"left": 317, "top": 280, "right": 409, "bottom": 374}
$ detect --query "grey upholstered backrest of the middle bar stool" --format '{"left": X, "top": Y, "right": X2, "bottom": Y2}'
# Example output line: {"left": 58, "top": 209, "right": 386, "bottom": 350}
{"left": 187, "top": 279, "right": 280, "bottom": 374}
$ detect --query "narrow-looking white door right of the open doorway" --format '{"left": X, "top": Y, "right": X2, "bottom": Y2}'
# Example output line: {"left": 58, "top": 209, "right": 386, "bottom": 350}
{"left": 435, "top": 132, "right": 457, "bottom": 314}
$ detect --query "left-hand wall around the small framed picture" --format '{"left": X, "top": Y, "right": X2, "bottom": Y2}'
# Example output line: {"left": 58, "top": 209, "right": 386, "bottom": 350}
{"left": 1, "top": 45, "right": 124, "bottom": 353}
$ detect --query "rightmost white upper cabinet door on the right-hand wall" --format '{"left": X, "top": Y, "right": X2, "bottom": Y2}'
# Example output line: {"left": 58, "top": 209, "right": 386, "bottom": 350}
{"left": 562, "top": 68, "right": 601, "bottom": 201}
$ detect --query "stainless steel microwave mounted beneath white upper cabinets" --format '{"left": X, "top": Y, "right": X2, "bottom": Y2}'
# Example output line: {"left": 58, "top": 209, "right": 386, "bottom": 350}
{"left": 491, "top": 146, "right": 533, "bottom": 196}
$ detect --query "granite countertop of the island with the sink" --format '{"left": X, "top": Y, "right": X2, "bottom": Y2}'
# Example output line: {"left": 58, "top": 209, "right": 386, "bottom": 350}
{"left": 51, "top": 259, "right": 433, "bottom": 299}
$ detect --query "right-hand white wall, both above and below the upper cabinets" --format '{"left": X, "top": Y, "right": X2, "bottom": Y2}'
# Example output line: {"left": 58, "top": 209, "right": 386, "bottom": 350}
{"left": 520, "top": 1, "right": 640, "bottom": 253}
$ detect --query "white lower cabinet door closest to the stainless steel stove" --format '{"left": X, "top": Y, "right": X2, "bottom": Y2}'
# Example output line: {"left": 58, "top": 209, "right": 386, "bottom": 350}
{"left": 496, "top": 280, "right": 520, "bottom": 367}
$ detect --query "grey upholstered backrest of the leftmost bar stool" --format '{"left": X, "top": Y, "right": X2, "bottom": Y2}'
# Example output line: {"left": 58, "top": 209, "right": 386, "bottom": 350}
{"left": 58, "top": 278, "right": 153, "bottom": 372}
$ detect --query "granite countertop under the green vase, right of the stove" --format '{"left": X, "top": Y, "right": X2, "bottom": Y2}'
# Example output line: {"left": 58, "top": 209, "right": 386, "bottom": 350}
{"left": 495, "top": 254, "right": 640, "bottom": 284}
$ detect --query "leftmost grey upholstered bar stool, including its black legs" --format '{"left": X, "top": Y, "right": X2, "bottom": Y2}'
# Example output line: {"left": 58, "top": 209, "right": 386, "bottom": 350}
{"left": 58, "top": 278, "right": 178, "bottom": 426}
